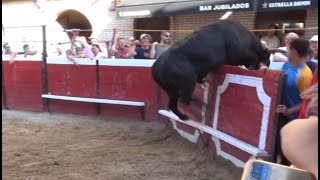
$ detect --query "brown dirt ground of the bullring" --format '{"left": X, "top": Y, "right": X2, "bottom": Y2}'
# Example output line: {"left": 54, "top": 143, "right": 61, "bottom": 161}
{"left": 2, "top": 110, "right": 242, "bottom": 180}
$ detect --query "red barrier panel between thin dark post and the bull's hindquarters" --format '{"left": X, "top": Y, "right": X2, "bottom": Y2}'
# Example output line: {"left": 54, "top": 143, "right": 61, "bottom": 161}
{"left": 99, "top": 66, "right": 157, "bottom": 121}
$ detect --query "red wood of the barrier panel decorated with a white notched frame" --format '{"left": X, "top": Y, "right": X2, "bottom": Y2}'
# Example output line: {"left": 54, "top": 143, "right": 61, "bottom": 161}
{"left": 207, "top": 66, "right": 282, "bottom": 162}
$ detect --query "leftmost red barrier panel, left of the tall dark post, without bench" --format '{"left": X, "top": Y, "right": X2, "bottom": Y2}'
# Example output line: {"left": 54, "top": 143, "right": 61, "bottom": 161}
{"left": 2, "top": 61, "right": 43, "bottom": 111}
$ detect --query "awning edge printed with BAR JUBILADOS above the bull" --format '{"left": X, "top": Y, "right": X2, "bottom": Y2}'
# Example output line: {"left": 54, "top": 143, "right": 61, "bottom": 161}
{"left": 116, "top": 0, "right": 254, "bottom": 17}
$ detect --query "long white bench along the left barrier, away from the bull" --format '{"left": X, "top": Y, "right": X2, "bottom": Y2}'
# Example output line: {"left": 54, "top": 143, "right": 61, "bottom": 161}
{"left": 41, "top": 94, "right": 145, "bottom": 120}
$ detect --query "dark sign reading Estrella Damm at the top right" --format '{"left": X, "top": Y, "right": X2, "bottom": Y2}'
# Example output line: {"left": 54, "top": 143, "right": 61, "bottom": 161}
{"left": 257, "top": 0, "right": 318, "bottom": 11}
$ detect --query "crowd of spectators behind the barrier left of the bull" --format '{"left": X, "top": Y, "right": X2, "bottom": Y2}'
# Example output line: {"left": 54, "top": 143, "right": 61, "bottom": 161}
{"left": 3, "top": 31, "right": 171, "bottom": 65}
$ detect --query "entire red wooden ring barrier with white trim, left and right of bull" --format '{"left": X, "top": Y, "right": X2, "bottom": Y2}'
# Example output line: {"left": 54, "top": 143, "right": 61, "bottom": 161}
{"left": 2, "top": 56, "right": 283, "bottom": 167}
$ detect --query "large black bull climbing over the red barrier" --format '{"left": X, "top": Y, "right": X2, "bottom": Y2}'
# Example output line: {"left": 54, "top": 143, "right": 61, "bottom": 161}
{"left": 152, "top": 20, "right": 284, "bottom": 120}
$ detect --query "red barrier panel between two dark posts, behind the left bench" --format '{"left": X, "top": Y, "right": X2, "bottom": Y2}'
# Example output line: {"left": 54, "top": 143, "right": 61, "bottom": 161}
{"left": 47, "top": 64, "right": 97, "bottom": 115}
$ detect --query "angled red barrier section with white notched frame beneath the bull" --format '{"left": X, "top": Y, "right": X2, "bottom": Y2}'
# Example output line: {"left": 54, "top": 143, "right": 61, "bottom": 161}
{"left": 161, "top": 66, "right": 283, "bottom": 167}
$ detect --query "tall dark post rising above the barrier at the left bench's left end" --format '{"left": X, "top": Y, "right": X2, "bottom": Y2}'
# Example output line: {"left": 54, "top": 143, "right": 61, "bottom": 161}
{"left": 42, "top": 25, "right": 49, "bottom": 112}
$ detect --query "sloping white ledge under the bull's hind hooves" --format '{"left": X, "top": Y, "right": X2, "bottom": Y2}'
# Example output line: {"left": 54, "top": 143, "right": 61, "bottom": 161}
{"left": 159, "top": 110, "right": 269, "bottom": 157}
